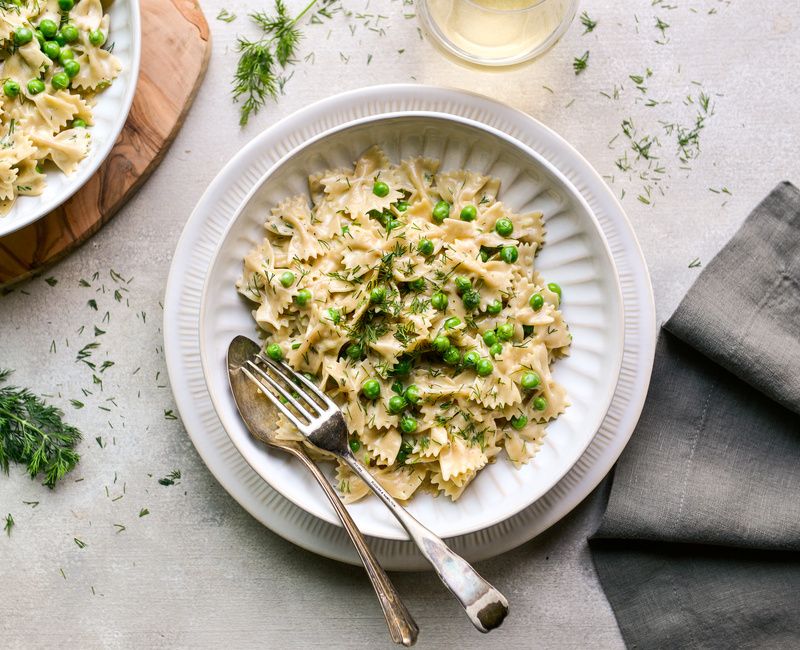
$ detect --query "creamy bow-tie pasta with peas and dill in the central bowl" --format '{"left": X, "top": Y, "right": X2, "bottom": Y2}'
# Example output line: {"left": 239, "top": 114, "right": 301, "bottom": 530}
{"left": 237, "top": 147, "right": 571, "bottom": 502}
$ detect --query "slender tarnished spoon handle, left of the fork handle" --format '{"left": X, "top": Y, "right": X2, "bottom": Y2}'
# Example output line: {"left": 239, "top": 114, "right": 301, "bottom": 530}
{"left": 287, "top": 446, "right": 419, "bottom": 647}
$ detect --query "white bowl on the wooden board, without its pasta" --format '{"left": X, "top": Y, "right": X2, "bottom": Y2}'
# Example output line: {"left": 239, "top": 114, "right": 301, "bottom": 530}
{"left": 0, "top": 0, "right": 142, "bottom": 237}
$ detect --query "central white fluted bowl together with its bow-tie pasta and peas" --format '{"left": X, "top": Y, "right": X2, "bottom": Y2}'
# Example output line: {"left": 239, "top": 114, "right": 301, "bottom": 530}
{"left": 200, "top": 113, "right": 624, "bottom": 539}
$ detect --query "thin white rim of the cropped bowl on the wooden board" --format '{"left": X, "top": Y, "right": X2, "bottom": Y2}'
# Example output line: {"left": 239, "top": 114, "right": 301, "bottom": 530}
{"left": 0, "top": 0, "right": 142, "bottom": 237}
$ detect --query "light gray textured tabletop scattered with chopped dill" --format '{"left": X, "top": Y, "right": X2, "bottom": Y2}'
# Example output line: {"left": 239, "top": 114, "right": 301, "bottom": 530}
{"left": 0, "top": 0, "right": 800, "bottom": 648}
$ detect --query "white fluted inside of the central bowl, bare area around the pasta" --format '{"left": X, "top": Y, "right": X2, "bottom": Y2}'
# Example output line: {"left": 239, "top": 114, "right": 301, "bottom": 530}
{"left": 199, "top": 112, "right": 624, "bottom": 539}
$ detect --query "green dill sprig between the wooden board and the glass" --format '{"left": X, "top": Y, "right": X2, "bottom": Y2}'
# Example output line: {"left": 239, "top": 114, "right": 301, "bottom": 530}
{"left": 233, "top": 0, "right": 317, "bottom": 126}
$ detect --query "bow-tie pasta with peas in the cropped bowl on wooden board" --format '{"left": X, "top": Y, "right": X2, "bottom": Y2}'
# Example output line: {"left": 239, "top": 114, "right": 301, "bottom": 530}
{"left": 0, "top": 0, "right": 122, "bottom": 215}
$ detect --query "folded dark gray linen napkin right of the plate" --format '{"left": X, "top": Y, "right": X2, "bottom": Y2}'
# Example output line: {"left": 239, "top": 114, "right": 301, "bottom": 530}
{"left": 590, "top": 183, "right": 800, "bottom": 648}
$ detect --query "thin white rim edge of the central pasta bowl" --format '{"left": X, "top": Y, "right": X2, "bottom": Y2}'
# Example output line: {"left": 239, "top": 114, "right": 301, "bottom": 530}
{"left": 198, "top": 110, "right": 625, "bottom": 540}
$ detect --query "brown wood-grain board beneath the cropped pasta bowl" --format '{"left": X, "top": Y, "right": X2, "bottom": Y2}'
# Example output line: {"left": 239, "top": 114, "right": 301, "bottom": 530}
{"left": 0, "top": 0, "right": 211, "bottom": 287}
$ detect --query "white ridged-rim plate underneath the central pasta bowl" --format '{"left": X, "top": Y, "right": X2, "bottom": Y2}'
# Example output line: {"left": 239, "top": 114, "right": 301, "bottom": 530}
{"left": 164, "top": 85, "right": 656, "bottom": 570}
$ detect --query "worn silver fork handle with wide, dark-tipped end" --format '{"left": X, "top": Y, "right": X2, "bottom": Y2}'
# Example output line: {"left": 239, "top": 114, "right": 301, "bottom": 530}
{"left": 342, "top": 452, "right": 508, "bottom": 632}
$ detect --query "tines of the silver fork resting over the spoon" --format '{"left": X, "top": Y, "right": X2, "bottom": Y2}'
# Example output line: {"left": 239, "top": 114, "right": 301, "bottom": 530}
{"left": 241, "top": 353, "right": 338, "bottom": 435}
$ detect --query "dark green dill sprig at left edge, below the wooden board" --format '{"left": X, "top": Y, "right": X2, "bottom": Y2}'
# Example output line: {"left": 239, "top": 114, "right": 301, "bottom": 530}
{"left": 0, "top": 370, "right": 81, "bottom": 488}
